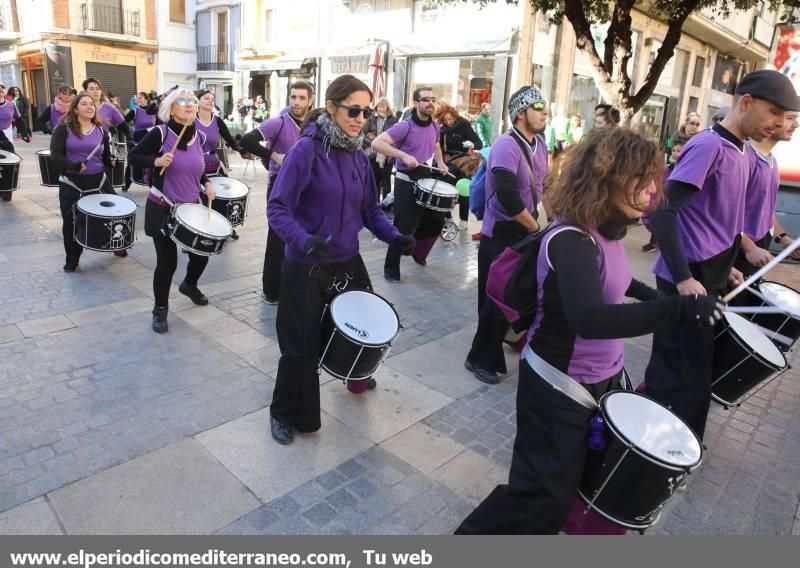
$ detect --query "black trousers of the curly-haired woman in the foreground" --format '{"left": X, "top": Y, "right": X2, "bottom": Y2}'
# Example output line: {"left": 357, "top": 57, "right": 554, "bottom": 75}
{"left": 456, "top": 361, "right": 620, "bottom": 534}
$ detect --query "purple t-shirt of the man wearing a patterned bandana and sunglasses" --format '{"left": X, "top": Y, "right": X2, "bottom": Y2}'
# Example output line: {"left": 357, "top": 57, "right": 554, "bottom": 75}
{"left": 481, "top": 131, "right": 547, "bottom": 237}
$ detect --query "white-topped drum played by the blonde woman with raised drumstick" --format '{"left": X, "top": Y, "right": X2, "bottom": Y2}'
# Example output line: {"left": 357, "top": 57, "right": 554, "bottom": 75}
{"left": 167, "top": 203, "right": 232, "bottom": 256}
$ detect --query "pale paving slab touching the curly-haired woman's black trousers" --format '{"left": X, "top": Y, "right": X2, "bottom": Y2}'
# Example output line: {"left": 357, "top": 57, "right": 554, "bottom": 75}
{"left": 431, "top": 450, "right": 508, "bottom": 505}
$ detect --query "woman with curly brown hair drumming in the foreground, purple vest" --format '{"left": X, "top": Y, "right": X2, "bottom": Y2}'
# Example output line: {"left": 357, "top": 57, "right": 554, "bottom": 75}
{"left": 456, "top": 126, "right": 724, "bottom": 534}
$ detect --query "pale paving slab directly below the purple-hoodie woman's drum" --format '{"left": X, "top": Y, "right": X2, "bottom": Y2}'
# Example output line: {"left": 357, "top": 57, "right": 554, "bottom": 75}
{"left": 320, "top": 367, "right": 452, "bottom": 443}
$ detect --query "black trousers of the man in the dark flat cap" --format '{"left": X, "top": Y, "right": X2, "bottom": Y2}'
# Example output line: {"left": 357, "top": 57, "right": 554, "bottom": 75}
{"left": 645, "top": 278, "right": 714, "bottom": 438}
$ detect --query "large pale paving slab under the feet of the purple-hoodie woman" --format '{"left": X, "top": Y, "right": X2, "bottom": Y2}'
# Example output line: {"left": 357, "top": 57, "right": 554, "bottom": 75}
{"left": 197, "top": 408, "right": 372, "bottom": 502}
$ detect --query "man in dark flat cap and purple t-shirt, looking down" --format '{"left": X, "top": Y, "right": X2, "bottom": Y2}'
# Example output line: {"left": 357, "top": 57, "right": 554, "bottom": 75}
{"left": 645, "top": 70, "right": 800, "bottom": 437}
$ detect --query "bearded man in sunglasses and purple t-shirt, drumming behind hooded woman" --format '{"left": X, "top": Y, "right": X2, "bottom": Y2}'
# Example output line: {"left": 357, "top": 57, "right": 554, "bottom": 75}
{"left": 372, "top": 87, "right": 448, "bottom": 282}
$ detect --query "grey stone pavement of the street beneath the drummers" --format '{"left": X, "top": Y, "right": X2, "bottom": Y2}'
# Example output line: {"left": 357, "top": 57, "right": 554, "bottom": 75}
{"left": 0, "top": 134, "right": 800, "bottom": 534}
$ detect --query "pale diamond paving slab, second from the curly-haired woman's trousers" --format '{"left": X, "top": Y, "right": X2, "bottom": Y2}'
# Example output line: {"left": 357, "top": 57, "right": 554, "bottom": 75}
{"left": 381, "top": 422, "right": 466, "bottom": 473}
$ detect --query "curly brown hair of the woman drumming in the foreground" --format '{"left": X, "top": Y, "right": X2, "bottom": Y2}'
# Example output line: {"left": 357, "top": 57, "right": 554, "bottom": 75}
{"left": 547, "top": 128, "right": 663, "bottom": 229}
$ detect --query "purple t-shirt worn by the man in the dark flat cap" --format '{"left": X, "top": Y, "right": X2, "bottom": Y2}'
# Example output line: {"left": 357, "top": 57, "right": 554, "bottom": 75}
{"left": 653, "top": 129, "right": 750, "bottom": 282}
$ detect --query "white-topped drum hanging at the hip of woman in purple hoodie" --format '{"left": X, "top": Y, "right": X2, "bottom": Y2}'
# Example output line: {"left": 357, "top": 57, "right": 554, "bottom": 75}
{"left": 320, "top": 290, "right": 400, "bottom": 381}
